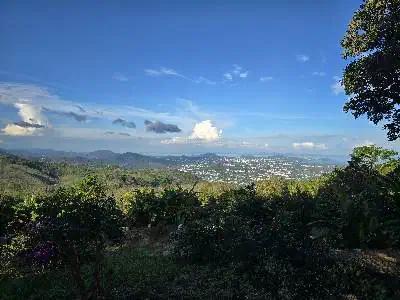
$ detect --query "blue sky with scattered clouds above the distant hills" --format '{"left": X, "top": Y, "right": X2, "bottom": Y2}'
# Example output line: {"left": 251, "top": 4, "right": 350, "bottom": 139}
{"left": 0, "top": 0, "right": 400, "bottom": 156}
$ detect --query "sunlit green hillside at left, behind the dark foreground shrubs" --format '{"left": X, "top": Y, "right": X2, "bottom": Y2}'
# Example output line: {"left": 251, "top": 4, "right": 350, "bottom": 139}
{"left": 0, "top": 152, "right": 198, "bottom": 194}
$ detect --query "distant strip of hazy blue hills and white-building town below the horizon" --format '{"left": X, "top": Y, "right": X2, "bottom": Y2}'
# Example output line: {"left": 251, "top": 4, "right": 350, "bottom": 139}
{"left": 0, "top": 150, "right": 342, "bottom": 185}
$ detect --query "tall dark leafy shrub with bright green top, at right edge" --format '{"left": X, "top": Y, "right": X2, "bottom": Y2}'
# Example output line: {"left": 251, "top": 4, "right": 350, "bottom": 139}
{"left": 314, "top": 147, "right": 400, "bottom": 248}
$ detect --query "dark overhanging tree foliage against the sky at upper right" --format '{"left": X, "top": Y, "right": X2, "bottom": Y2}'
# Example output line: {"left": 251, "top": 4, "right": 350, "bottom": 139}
{"left": 341, "top": 0, "right": 400, "bottom": 140}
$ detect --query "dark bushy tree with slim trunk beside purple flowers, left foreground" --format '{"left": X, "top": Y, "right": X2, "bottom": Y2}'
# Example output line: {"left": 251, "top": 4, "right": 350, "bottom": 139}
{"left": 31, "top": 176, "right": 121, "bottom": 299}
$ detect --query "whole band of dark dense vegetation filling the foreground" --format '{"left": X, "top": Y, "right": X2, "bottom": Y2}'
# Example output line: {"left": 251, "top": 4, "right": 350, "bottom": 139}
{"left": 0, "top": 146, "right": 400, "bottom": 299}
